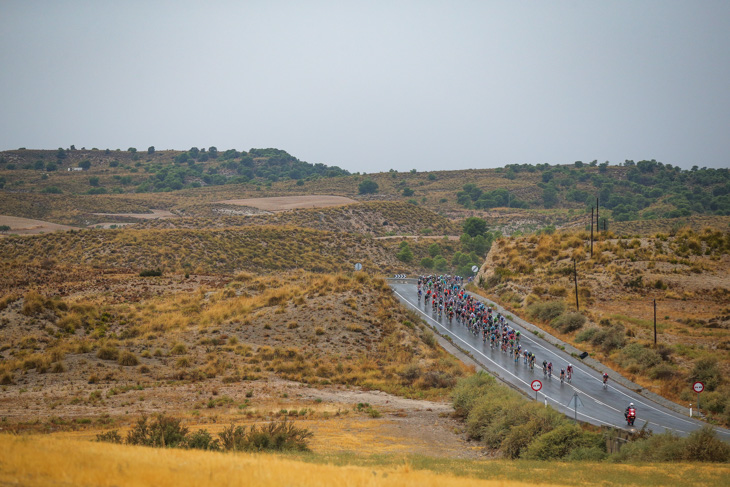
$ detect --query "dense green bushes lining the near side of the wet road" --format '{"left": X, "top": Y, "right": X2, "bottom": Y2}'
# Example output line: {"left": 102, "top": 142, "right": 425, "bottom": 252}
{"left": 453, "top": 372, "right": 730, "bottom": 463}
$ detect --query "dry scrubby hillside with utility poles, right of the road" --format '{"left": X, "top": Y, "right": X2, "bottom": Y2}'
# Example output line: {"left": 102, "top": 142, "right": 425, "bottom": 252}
{"left": 479, "top": 228, "right": 730, "bottom": 422}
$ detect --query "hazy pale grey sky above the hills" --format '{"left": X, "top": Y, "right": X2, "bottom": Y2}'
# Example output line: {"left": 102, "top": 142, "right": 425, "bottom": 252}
{"left": 0, "top": 0, "right": 730, "bottom": 172}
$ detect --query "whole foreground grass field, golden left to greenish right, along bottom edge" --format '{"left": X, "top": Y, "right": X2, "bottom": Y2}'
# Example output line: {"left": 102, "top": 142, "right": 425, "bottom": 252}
{"left": 0, "top": 435, "right": 730, "bottom": 487}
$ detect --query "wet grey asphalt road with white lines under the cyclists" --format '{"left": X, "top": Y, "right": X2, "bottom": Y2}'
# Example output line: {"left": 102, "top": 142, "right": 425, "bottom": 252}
{"left": 390, "top": 280, "right": 730, "bottom": 441}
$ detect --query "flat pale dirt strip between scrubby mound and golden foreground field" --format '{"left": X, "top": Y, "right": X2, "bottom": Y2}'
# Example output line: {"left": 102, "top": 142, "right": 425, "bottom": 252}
{"left": 0, "top": 374, "right": 480, "bottom": 458}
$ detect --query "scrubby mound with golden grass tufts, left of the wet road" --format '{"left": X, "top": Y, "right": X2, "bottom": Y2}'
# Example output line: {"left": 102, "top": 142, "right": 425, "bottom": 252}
{"left": 0, "top": 270, "right": 467, "bottom": 427}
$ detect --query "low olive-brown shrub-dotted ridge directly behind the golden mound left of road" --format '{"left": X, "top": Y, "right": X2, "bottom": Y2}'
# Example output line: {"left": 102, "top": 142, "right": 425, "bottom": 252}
{"left": 0, "top": 226, "right": 404, "bottom": 274}
